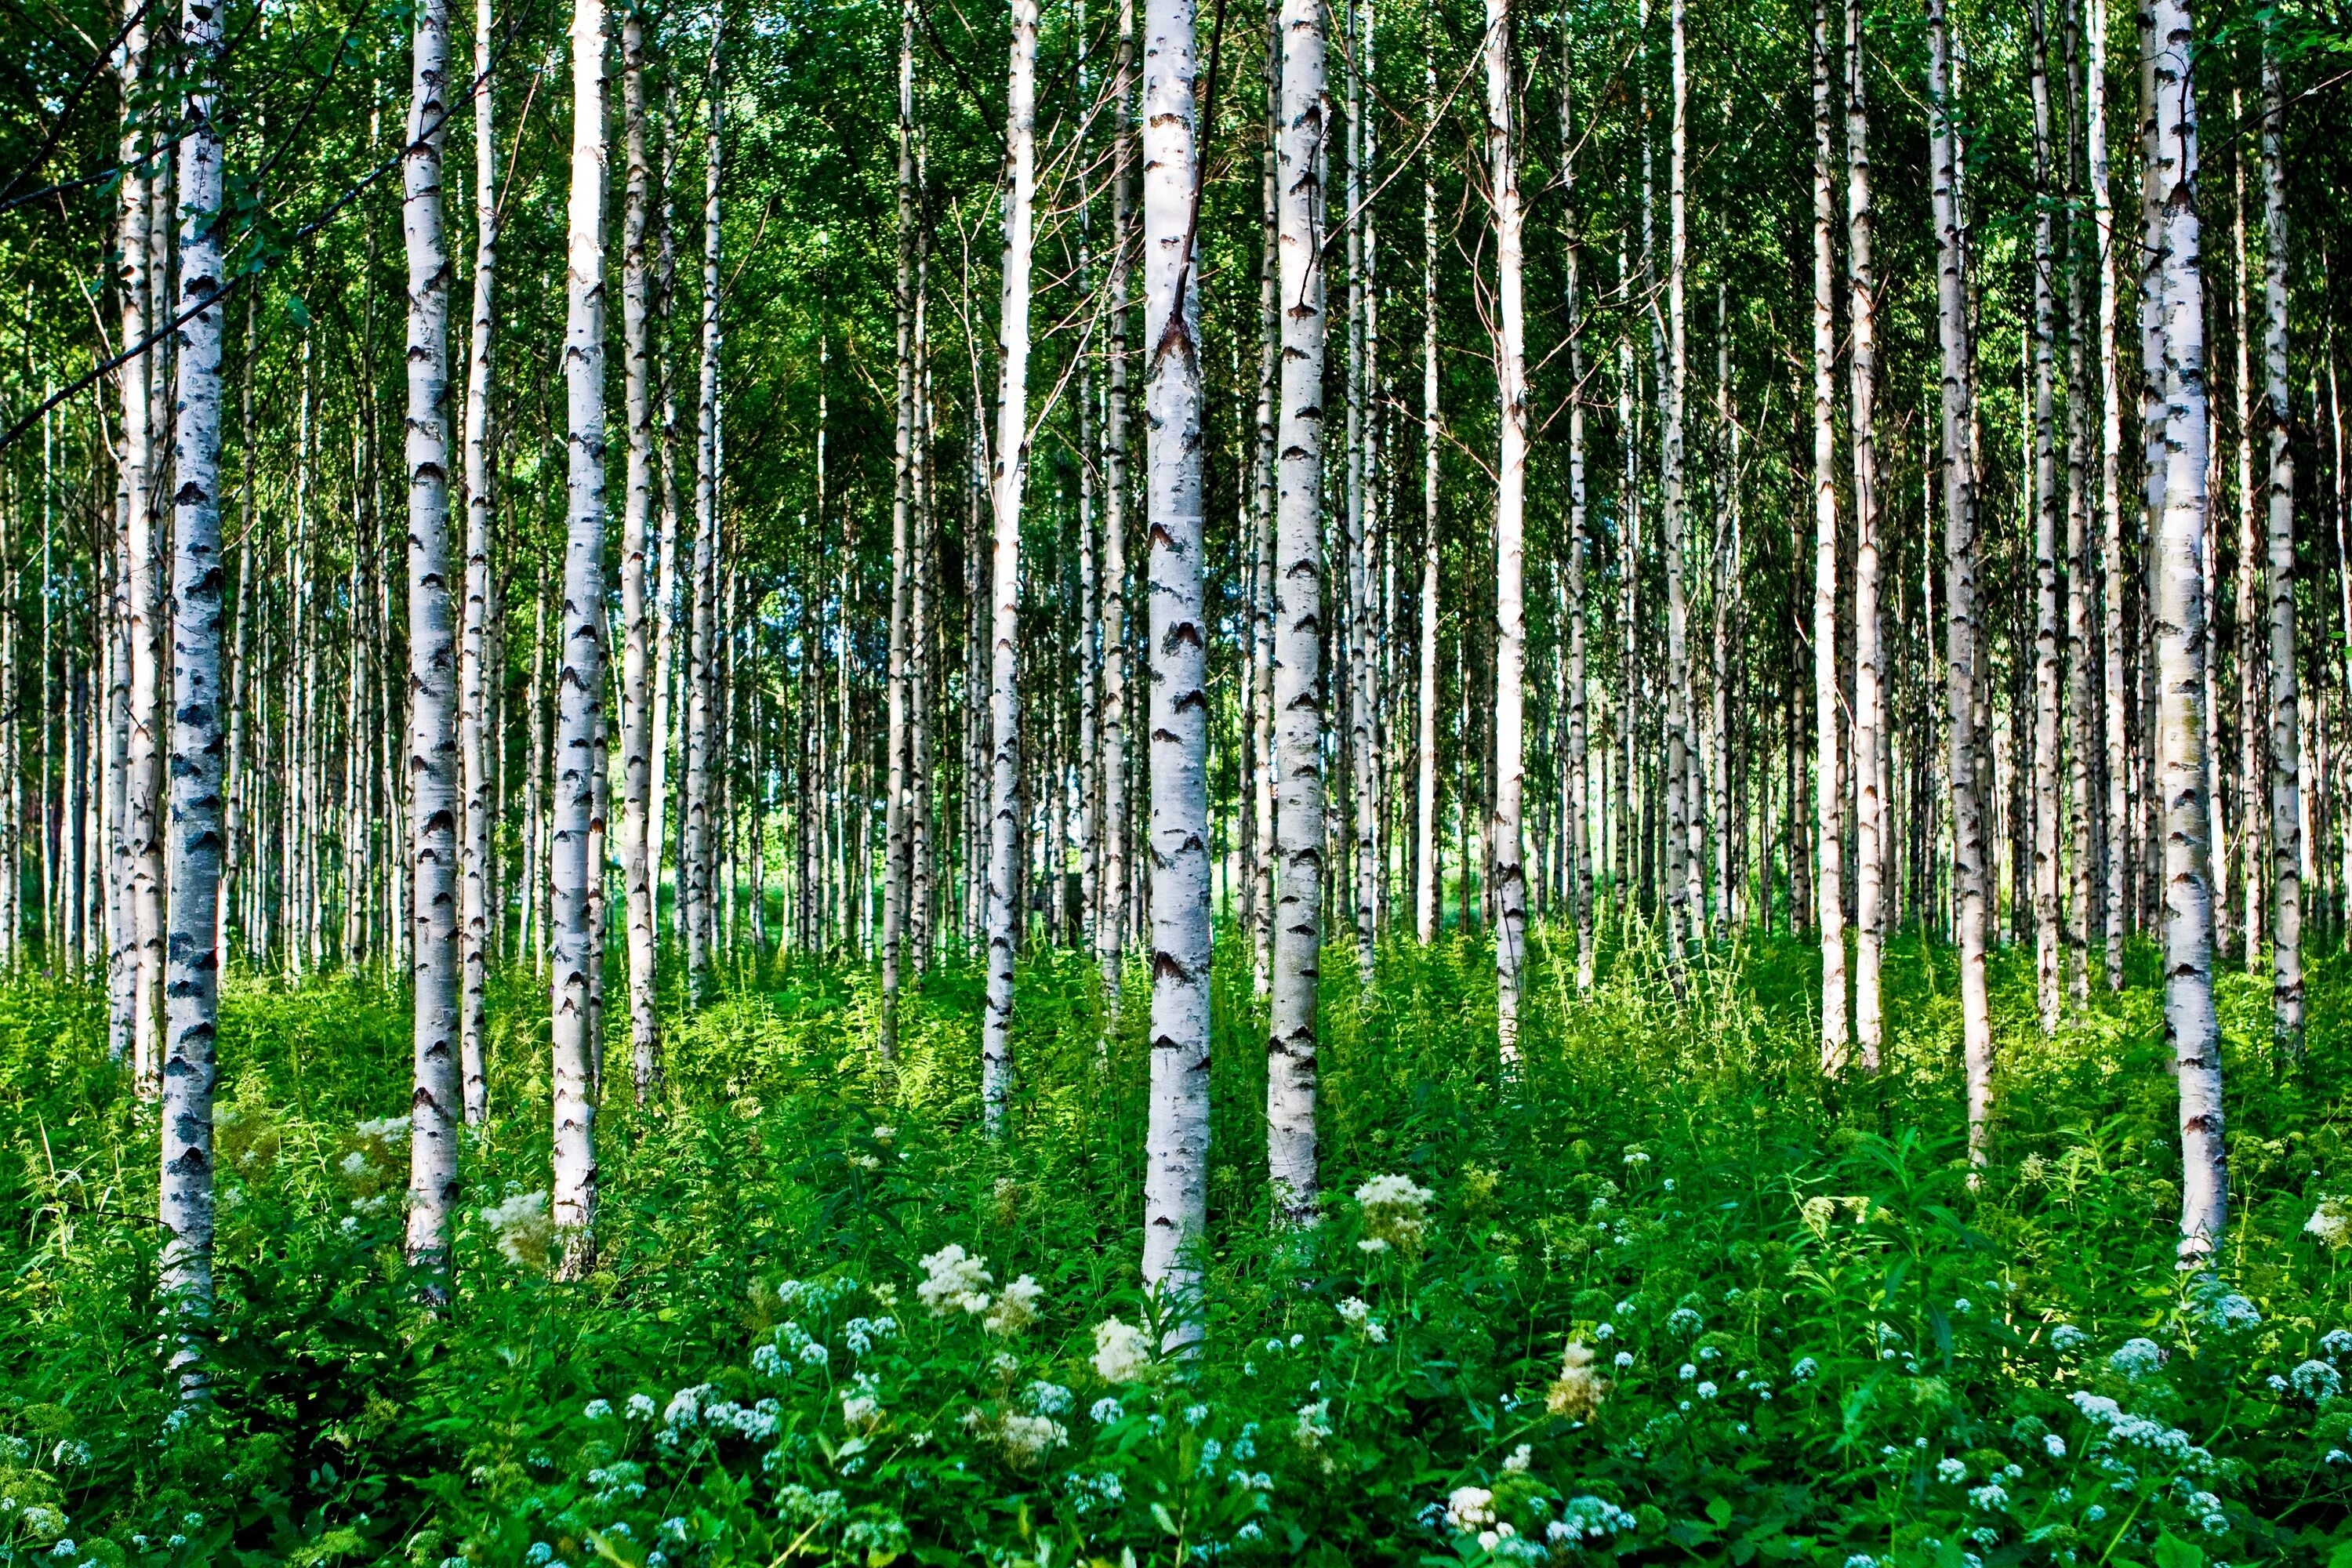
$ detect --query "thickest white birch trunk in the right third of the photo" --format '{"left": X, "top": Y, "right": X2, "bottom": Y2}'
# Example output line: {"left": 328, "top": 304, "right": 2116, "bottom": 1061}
{"left": 2147, "top": 0, "right": 2230, "bottom": 1258}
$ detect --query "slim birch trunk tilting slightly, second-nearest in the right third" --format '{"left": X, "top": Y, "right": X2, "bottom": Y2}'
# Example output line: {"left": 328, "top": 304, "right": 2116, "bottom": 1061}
{"left": 1926, "top": 0, "right": 1992, "bottom": 1163}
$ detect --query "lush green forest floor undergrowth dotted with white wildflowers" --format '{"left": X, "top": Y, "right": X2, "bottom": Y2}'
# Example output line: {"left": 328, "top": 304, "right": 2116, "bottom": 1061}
{"left": 0, "top": 935, "right": 2352, "bottom": 1568}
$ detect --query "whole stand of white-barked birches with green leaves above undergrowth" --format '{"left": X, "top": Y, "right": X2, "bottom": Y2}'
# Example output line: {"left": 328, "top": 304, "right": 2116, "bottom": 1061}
{"left": 0, "top": 0, "right": 2352, "bottom": 1375}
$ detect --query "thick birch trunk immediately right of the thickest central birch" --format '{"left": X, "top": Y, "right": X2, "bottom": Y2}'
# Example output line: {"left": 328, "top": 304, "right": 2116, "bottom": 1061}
{"left": 1265, "top": 0, "right": 1327, "bottom": 1225}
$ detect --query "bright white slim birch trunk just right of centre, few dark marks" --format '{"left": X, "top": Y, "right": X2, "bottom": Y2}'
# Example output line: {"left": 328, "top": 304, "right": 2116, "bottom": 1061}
{"left": 1486, "top": 0, "right": 1534, "bottom": 1065}
